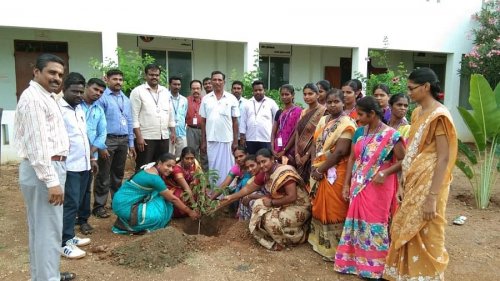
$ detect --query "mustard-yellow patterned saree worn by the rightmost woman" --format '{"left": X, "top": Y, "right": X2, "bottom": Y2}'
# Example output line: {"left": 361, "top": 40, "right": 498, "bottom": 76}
{"left": 384, "top": 105, "right": 457, "bottom": 281}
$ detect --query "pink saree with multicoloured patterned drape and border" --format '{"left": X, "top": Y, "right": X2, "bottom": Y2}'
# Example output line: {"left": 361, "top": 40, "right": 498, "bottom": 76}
{"left": 334, "top": 127, "right": 400, "bottom": 278}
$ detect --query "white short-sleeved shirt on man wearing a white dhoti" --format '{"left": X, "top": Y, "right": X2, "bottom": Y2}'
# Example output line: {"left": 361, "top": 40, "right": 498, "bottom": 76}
{"left": 200, "top": 92, "right": 240, "bottom": 142}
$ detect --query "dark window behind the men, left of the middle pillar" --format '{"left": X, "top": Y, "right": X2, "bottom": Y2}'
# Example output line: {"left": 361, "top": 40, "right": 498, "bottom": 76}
{"left": 142, "top": 50, "right": 193, "bottom": 96}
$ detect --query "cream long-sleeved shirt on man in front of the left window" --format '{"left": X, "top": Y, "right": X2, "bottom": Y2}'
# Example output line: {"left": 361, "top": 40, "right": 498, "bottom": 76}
{"left": 130, "top": 83, "right": 175, "bottom": 140}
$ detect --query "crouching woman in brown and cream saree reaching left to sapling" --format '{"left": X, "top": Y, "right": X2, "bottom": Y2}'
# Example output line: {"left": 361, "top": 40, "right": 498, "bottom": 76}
{"left": 221, "top": 148, "right": 311, "bottom": 250}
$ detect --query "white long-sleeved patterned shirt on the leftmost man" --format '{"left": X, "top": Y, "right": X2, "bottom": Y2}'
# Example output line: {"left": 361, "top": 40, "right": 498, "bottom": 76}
{"left": 14, "top": 81, "right": 69, "bottom": 188}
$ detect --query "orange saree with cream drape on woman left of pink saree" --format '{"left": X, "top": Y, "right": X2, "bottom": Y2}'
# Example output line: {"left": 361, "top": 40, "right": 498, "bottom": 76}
{"left": 308, "top": 116, "right": 356, "bottom": 259}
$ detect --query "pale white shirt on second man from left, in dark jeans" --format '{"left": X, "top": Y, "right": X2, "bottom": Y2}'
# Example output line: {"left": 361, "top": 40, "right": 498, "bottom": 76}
{"left": 59, "top": 98, "right": 90, "bottom": 172}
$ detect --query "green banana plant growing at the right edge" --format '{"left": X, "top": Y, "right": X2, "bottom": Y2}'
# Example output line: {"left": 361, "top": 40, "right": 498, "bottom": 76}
{"left": 456, "top": 74, "right": 500, "bottom": 209}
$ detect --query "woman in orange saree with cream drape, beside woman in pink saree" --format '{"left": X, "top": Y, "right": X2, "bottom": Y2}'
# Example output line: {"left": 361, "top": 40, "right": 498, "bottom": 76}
{"left": 308, "top": 89, "right": 356, "bottom": 260}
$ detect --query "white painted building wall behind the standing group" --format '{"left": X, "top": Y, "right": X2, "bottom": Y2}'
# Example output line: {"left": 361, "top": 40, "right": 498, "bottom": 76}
{"left": 0, "top": 0, "right": 483, "bottom": 161}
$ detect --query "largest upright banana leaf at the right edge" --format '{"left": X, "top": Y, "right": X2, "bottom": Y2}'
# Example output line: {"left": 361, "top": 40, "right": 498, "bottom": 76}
{"left": 469, "top": 74, "right": 500, "bottom": 138}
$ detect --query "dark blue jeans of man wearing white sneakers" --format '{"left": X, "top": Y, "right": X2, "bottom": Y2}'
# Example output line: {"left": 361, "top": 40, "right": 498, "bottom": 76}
{"left": 62, "top": 168, "right": 90, "bottom": 246}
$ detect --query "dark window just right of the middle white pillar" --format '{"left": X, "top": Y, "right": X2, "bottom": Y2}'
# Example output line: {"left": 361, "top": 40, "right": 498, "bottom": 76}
{"left": 259, "top": 56, "right": 290, "bottom": 90}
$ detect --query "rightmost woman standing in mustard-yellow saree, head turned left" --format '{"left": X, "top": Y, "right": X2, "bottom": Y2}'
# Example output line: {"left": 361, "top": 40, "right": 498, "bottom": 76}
{"left": 384, "top": 68, "right": 457, "bottom": 280}
